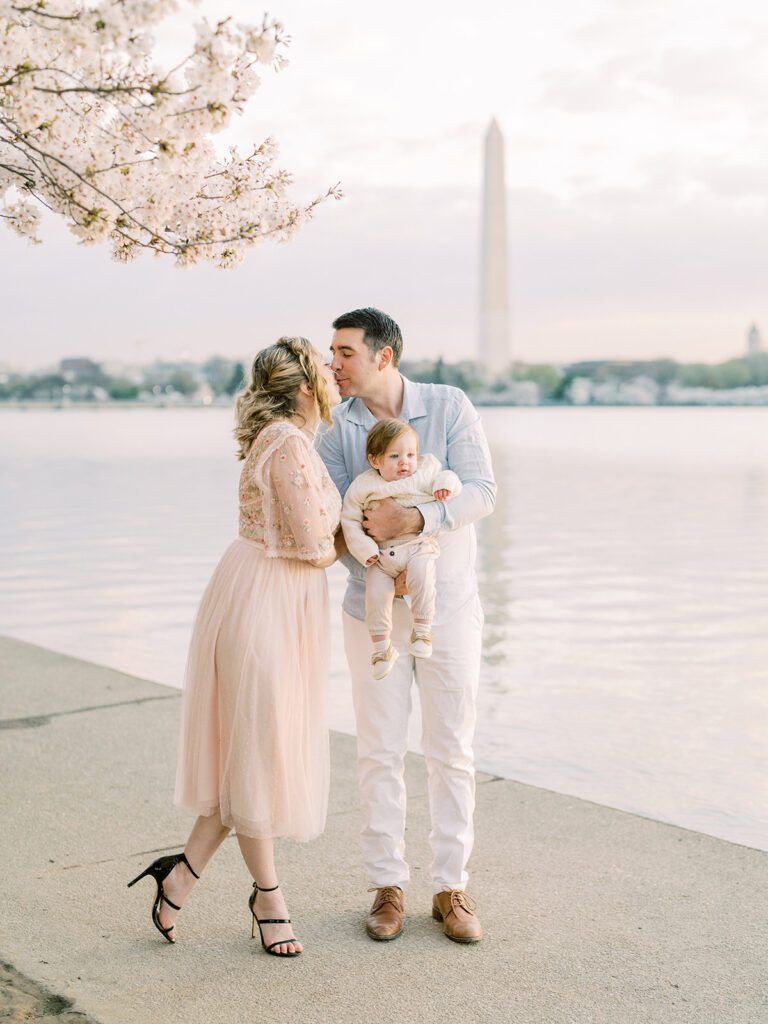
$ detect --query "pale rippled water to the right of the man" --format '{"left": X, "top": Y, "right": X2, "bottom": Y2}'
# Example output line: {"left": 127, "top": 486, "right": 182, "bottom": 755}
{"left": 478, "top": 410, "right": 768, "bottom": 848}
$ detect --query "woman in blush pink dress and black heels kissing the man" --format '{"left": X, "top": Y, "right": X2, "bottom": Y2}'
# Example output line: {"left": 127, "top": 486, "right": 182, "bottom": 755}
{"left": 129, "top": 338, "right": 343, "bottom": 956}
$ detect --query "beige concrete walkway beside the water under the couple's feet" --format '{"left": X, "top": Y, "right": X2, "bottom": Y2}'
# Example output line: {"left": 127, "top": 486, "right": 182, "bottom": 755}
{"left": 0, "top": 639, "right": 768, "bottom": 1024}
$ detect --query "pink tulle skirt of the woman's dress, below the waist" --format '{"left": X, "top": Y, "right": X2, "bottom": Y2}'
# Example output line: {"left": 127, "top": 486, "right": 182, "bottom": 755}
{"left": 175, "top": 538, "right": 330, "bottom": 841}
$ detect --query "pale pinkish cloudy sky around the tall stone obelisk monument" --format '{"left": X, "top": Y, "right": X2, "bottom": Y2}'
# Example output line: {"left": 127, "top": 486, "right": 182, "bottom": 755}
{"left": 0, "top": 0, "right": 768, "bottom": 368}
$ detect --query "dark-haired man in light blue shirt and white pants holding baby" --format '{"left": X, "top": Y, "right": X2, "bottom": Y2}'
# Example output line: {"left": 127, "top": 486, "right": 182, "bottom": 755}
{"left": 318, "top": 307, "right": 496, "bottom": 942}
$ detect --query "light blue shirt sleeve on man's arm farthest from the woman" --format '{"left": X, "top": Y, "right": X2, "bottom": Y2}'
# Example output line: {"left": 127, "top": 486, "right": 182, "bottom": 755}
{"left": 417, "top": 394, "right": 497, "bottom": 537}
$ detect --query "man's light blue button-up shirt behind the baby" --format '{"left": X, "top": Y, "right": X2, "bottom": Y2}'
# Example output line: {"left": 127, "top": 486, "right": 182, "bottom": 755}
{"left": 317, "top": 377, "right": 496, "bottom": 624}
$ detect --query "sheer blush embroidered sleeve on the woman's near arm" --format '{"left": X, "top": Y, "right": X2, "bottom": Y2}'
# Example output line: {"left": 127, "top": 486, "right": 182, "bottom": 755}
{"left": 257, "top": 433, "right": 338, "bottom": 561}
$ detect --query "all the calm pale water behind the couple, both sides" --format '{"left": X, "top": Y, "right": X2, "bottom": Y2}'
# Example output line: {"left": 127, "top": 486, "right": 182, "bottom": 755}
{"left": 0, "top": 409, "right": 768, "bottom": 849}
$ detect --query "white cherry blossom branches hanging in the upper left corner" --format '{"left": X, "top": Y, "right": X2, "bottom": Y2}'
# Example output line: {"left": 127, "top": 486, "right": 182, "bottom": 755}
{"left": 0, "top": 0, "right": 341, "bottom": 267}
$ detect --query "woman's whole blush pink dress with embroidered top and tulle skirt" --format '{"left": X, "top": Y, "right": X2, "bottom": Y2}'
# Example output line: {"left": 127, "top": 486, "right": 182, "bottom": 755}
{"left": 175, "top": 420, "right": 341, "bottom": 841}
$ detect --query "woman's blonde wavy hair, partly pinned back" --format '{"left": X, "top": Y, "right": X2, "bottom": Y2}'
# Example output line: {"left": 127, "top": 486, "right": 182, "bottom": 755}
{"left": 234, "top": 338, "right": 333, "bottom": 459}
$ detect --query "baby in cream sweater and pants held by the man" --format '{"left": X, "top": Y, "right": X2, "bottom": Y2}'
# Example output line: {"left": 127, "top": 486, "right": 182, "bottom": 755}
{"left": 341, "top": 420, "right": 462, "bottom": 679}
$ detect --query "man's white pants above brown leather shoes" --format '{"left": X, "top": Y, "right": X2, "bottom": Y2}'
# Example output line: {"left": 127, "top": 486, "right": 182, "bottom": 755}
{"left": 343, "top": 597, "right": 483, "bottom": 892}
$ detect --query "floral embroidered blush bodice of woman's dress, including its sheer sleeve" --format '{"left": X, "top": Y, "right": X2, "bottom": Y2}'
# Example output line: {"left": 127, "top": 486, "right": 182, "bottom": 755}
{"left": 240, "top": 420, "right": 341, "bottom": 561}
